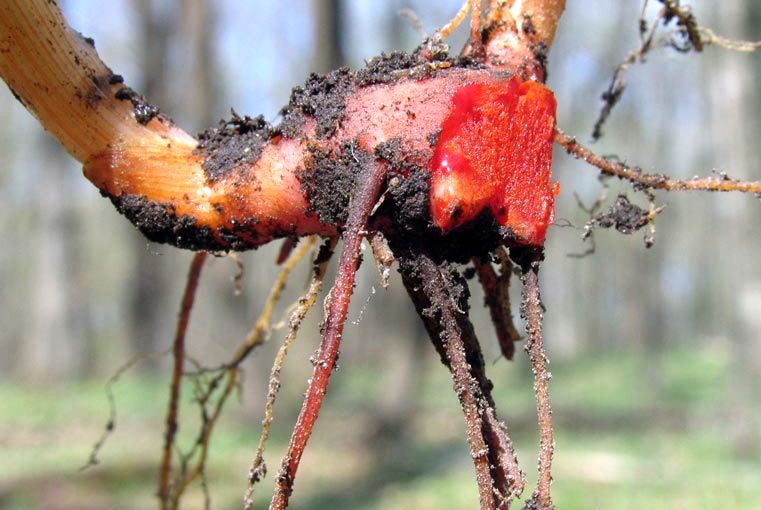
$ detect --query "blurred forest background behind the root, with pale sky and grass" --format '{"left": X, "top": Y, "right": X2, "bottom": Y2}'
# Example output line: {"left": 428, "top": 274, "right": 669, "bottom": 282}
{"left": 0, "top": 0, "right": 761, "bottom": 509}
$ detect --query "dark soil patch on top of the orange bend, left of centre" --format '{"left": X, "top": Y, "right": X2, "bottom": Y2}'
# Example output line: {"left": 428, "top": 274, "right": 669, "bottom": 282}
{"left": 195, "top": 111, "right": 273, "bottom": 181}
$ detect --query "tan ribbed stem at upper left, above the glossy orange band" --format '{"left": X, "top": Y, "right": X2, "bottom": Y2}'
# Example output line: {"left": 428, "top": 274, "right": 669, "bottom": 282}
{"left": 0, "top": 0, "right": 196, "bottom": 163}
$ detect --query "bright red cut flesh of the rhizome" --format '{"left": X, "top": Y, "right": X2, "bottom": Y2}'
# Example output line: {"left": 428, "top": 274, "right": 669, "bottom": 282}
{"left": 430, "top": 77, "right": 559, "bottom": 246}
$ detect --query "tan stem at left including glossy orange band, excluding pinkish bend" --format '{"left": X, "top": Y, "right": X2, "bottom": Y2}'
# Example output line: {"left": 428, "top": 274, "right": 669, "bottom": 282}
{"left": 0, "top": 0, "right": 217, "bottom": 228}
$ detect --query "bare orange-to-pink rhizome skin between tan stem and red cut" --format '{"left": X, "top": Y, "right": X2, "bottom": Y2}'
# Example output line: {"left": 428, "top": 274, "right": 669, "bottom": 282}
{"left": 84, "top": 68, "right": 540, "bottom": 250}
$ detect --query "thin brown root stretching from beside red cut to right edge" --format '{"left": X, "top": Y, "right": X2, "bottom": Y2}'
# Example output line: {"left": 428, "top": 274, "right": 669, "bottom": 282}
{"left": 555, "top": 129, "right": 761, "bottom": 194}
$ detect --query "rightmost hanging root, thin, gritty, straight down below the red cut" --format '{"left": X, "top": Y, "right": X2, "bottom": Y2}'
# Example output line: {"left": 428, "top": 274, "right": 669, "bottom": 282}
{"left": 511, "top": 249, "right": 555, "bottom": 510}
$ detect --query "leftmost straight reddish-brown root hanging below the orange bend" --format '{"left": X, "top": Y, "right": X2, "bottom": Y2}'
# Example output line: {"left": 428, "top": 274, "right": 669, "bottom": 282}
{"left": 159, "top": 251, "right": 206, "bottom": 509}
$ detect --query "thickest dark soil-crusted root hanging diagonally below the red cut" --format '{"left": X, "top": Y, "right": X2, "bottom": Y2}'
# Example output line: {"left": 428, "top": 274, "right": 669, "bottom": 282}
{"left": 397, "top": 253, "right": 524, "bottom": 509}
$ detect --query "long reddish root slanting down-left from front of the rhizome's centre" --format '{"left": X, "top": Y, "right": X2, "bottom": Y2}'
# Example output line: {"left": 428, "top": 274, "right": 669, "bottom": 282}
{"left": 270, "top": 161, "right": 387, "bottom": 510}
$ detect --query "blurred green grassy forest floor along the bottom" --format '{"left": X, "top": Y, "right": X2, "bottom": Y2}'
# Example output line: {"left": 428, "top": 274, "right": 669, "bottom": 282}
{"left": 0, "top": 344, "right": 761, "bottom": 510}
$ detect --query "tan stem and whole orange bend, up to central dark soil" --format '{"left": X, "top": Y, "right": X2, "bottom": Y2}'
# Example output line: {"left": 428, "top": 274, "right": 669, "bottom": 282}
{"left": 0, "top": 0, "right": 326, "bottom": 251}
